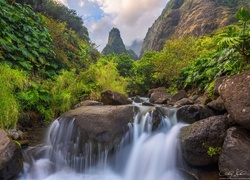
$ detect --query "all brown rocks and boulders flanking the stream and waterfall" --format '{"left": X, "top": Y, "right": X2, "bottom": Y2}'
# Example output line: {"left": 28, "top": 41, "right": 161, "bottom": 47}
{"left": 0, "top": 72, "right": 250, "bottom": 179}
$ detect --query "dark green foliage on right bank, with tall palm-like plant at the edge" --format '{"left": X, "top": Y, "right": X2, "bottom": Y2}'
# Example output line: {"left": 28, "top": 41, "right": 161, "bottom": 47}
{"left": 178, "top": 9, "right": 250, "bottom": 91}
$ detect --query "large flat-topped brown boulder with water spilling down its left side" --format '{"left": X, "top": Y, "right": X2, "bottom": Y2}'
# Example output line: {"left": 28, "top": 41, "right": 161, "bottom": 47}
{"left": 60, "top": 105, "right": 134, "bottom": 153}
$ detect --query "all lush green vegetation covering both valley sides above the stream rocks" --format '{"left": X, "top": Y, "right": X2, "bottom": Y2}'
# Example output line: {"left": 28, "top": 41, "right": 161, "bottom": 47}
{"left": 0, "top": 0, "right": 250, "bottom": 130}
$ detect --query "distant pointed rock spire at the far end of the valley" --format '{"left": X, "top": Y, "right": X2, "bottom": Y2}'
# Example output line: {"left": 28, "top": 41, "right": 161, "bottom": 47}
{"left": 102, "top": 28, "right": 138, "bottom": 59}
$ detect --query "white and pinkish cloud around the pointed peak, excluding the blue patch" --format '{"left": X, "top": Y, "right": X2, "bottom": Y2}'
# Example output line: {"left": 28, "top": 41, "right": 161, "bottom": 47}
{"left": 85, "top": 0, "right": 168, "bottom": 50}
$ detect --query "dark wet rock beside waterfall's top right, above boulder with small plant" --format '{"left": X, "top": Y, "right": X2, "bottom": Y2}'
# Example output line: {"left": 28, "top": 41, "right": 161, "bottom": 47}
{"left": 176, "top": 105, "right": 214, "bottom": 124}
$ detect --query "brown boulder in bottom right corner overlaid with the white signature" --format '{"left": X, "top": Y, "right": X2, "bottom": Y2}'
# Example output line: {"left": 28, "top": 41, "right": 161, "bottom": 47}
{"left": 219, "top": 127, "right": 250, "bottom": 179}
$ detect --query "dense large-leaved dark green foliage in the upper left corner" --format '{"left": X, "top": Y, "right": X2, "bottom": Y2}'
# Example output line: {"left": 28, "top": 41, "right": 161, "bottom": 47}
{"left": 0, "top": 0, "right": 56, "bottom": 74}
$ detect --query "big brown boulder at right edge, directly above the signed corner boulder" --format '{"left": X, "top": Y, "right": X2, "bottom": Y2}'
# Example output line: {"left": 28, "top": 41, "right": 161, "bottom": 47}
{"left": 219, "top": 71, "right": 250, "bottom": 129}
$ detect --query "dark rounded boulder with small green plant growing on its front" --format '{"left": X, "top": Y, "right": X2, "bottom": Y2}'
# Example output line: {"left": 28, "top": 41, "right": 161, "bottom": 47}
{"left": 180, "top": 116, "right": 228, "bottom": 167}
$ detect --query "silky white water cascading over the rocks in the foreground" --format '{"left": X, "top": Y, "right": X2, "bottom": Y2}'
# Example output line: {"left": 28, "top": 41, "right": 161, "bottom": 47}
{"left": 19, "top": 106, "right": 186, "bottom": 180}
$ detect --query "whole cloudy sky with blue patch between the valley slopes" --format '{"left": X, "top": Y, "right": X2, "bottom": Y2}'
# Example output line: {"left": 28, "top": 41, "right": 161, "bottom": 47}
{"left": 56, "top": 0, "right": 169, "bottom": 51}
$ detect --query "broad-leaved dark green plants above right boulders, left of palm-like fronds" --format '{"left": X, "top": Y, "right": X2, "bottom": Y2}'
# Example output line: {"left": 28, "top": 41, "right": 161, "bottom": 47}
{"left": 178, "top": 49, "right": 241, "bottom": 91}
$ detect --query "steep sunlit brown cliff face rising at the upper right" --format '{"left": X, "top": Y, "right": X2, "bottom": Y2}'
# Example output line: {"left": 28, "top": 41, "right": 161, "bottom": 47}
{"left": 141, "top": 0, "right": 250, "bottom": 55}
